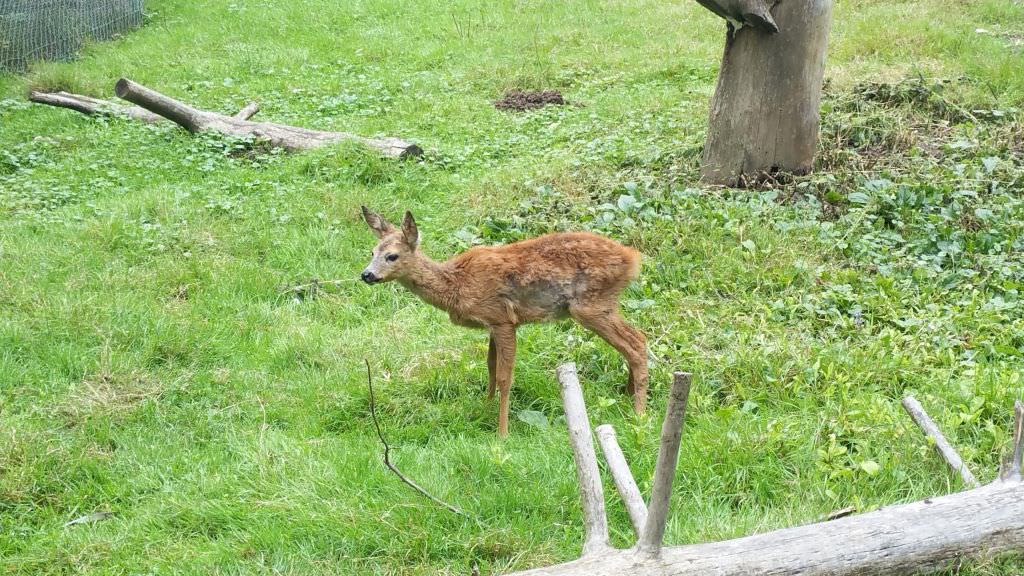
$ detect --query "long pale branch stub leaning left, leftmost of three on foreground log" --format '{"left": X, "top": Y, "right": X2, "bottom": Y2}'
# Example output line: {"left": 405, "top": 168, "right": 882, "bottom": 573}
{"left": 556, "top": 362, "right": 610, "bottom": 558}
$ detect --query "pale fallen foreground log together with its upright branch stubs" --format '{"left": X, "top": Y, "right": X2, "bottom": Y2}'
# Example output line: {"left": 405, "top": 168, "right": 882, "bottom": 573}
{"left": 501, "top": 365, "right": 1024, "bottom": 576}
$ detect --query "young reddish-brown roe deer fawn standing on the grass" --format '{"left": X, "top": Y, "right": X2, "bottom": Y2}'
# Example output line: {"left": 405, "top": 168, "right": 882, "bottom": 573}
{"left": 361, "top": 206, "right": 647, "bottom": 437}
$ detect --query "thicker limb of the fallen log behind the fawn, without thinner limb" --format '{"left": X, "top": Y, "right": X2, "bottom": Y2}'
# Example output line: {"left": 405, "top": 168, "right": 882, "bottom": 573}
{"left": 114, "top": 78, "right": 423, "bottom": 158}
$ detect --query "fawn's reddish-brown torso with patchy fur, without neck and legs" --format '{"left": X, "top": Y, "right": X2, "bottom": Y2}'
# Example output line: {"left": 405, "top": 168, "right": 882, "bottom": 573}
{"left": 451, "top": 233, "right": 640, "bottom": 324}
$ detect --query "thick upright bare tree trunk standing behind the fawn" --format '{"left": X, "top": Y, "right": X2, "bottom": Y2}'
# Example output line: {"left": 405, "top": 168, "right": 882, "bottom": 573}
{"left": 701, "top": 0, "right": 833, "bottom": 186}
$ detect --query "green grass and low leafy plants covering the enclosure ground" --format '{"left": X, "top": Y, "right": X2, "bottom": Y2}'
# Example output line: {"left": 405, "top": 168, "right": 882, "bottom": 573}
{"left": 0, "top": 0, "right": 1024, "bottom": 575}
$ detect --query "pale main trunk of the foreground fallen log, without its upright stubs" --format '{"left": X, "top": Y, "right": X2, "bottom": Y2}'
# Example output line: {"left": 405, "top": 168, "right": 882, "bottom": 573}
{"left": 501, "top": 482, "right": 1024, "bottom": 576}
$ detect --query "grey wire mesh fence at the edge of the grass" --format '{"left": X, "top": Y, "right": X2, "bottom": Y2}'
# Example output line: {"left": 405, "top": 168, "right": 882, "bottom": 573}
{"left": 0, "top": 0, "right": 142, "bottom": 72}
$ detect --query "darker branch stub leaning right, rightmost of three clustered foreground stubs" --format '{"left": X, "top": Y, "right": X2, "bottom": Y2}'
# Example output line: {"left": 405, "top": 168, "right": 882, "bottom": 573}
{"left": 637, "top": 372, "right": 690, "bottom": 556}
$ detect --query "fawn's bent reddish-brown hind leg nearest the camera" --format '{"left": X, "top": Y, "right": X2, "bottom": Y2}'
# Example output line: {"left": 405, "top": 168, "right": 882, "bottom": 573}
{"left": 569, "top": 305, "right": 647, "bottom": 414}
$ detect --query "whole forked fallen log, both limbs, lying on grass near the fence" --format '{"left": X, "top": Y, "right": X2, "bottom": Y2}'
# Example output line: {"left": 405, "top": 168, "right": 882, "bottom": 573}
{"left": 30, "top": 78, "right": 423, "bottom": 158}
